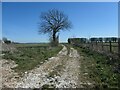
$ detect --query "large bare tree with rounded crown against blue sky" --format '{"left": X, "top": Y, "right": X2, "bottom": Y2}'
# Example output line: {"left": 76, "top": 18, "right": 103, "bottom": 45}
{"left": 39, "top": 9, "right": 71, "bottom": 44}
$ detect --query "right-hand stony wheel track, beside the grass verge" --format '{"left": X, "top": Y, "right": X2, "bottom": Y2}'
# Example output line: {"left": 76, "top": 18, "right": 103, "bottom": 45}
{"left": 54, "top": 48, "right": 81, "bottom": 88}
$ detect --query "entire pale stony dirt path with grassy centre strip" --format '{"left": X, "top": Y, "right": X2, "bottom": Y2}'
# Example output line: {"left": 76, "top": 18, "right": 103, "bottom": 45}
{"left": 3, "top": 46, "right": 90, "bottom": 88}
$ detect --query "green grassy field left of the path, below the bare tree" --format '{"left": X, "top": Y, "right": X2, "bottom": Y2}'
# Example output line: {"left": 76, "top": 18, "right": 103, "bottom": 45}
{"left": 3, "top": 44, "right": 62, "bottom": 73}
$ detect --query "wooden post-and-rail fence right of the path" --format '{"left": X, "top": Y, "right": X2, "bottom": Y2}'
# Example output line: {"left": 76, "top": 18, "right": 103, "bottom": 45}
{"left": 76, "top": 41, "right": 119, "bottom": 56}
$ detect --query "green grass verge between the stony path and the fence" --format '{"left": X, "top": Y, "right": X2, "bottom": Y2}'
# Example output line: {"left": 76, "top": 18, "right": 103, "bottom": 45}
{"left": 74, "top": 47, "right": 120, "bottom": 89}
